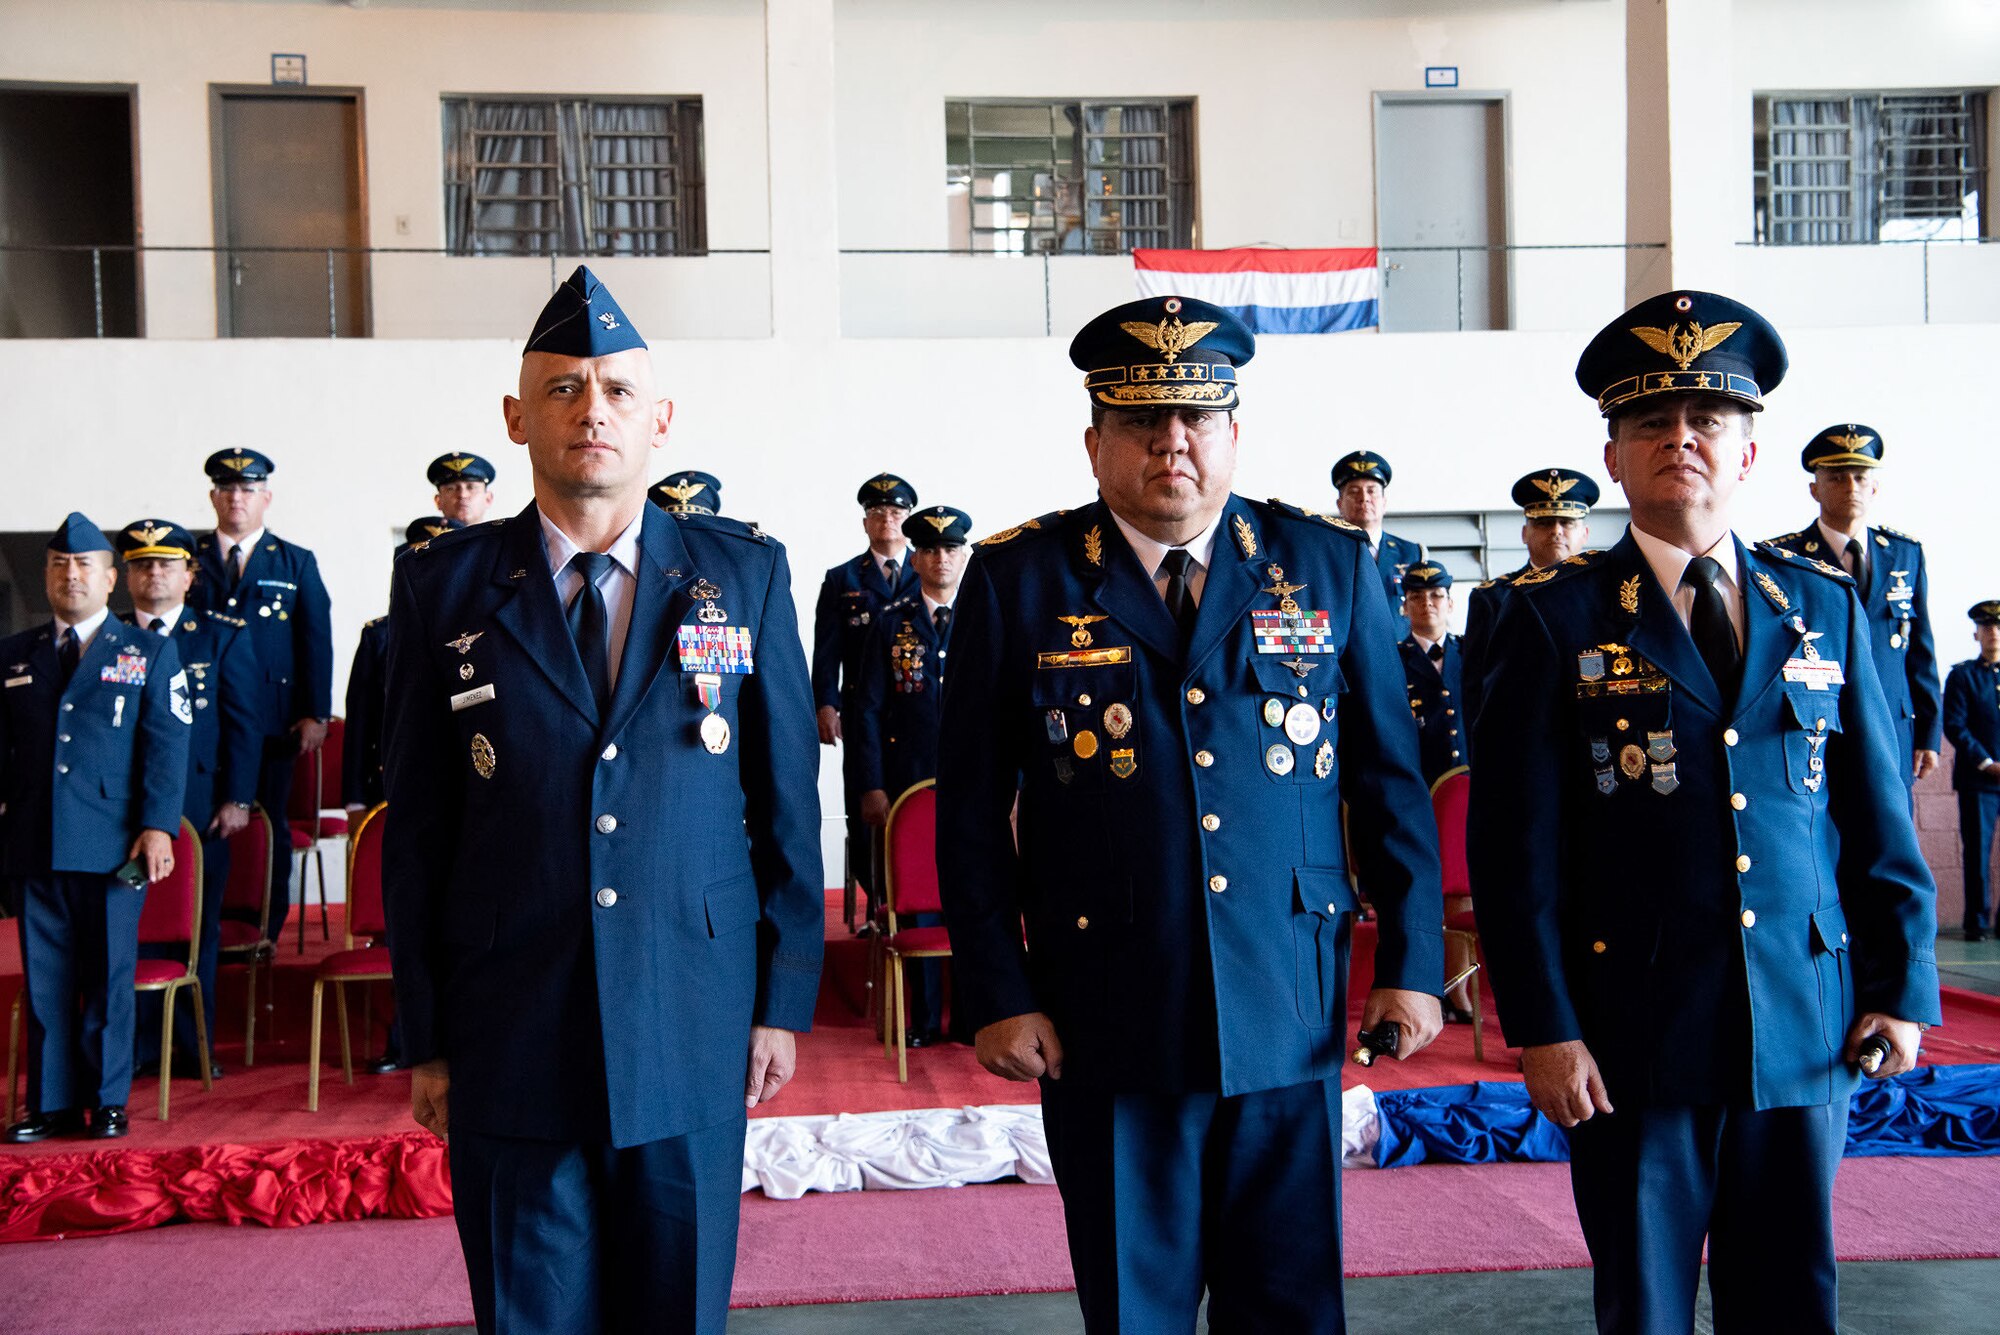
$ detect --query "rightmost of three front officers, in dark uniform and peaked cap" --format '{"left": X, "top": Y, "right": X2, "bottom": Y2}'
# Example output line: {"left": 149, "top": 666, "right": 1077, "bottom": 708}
{"left": 1470, "top": 292, "right": 1938, "bottom": 1333}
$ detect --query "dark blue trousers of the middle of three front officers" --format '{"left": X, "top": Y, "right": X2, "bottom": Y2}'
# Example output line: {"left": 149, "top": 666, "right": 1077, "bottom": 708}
{"left": 1042, "top": 1079, "right": 1346, "bottom": 1335}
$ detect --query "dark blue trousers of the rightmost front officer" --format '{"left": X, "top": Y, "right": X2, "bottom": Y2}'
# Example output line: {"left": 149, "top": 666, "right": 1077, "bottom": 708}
{"left": 1570, "top": 1099, "right": 1848, "bottom": 1335}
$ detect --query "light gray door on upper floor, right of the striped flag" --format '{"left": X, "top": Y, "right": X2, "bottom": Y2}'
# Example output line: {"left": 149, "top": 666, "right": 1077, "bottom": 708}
{"left": 1376, "top": 98, "right": 1508, "bottom": 332}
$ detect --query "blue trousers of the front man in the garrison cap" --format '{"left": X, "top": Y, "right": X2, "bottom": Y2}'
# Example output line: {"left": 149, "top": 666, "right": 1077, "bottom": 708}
{"left": 450, "top": 1113, "right": 744, "bottom": 1335}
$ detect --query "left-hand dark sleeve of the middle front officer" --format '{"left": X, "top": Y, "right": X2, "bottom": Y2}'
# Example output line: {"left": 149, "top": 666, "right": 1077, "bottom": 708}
{"left": 938, "top": 556, "right": 1042, "bottom": 1029}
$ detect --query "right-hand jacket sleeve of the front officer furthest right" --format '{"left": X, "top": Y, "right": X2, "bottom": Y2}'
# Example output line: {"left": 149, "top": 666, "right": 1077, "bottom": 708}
{"left": 1828, "top": 586, "right": 1942, "bottom": 1023}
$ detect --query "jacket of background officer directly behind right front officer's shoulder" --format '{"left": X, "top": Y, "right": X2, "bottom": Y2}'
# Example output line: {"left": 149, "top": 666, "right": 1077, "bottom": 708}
{"left": 1772, "top": 524, "right": 1944, "bottom": 767}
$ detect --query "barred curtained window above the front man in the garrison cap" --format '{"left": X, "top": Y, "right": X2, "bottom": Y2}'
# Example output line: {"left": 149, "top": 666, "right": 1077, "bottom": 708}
{"left": 444, "top": 96, "right": 708, "bottom": 256}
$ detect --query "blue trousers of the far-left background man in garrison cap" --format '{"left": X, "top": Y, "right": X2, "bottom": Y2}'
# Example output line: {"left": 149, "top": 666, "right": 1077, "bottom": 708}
{"left": 12, "top": 871, "right": 146, "bottom": 1113}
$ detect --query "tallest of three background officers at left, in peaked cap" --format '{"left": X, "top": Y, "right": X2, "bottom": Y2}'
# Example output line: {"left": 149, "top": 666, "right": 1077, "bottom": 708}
{"left": 192, "top": 448, "right": 334, "bottom": 941}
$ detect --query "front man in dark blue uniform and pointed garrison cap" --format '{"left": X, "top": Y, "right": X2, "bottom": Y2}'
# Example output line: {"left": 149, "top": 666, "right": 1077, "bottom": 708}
{"left": 384, "top": 268, "right": 826, "bottom": 1333}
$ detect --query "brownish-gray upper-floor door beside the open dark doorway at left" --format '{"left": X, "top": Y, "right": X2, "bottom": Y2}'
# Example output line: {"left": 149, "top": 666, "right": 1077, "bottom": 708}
{"left": 214, "top": 90, "right": 368, "bottom": 338}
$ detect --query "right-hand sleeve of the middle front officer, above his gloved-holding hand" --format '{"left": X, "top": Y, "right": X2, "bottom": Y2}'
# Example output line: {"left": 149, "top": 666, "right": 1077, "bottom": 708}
{"left": 1340, "top": 544, "right": 1444, "bottom": 995}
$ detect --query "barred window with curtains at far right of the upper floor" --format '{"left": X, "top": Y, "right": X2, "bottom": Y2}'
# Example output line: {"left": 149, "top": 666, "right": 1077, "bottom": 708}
{"left": 1754, "top": 92, "right": 1986, "bottom": 246}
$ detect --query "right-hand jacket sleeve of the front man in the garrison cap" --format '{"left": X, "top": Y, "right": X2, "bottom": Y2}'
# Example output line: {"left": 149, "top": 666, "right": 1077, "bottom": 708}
{"left": 736, "top": 548, "right": 826, "bottom": 1033}
